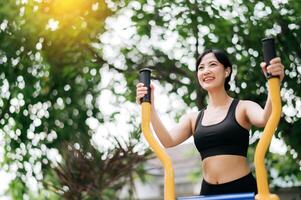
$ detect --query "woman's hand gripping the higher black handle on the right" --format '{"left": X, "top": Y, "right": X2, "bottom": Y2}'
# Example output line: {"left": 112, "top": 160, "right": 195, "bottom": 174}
{"left": 260, "top": 57, "right": 284, "bottom": 81}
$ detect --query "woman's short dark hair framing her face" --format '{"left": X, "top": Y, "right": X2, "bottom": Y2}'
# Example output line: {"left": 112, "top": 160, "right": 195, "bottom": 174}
{"left": 195, "top": 49, "right": 232, "bottom": 90}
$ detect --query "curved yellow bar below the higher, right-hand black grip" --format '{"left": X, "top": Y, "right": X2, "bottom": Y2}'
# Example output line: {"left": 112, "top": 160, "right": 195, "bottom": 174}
{"left": 255, "top": 77, "right": 281, "bottom": 200}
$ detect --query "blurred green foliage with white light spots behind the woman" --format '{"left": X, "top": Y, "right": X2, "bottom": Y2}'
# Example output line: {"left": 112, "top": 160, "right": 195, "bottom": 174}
{"left": 0, "top": 0, "right": 301, "bottom": 199}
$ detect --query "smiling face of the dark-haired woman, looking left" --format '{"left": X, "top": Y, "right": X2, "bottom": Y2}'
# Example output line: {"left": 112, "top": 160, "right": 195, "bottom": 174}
{"left": 197, "top": 53, "right": 230, "bottom": 91}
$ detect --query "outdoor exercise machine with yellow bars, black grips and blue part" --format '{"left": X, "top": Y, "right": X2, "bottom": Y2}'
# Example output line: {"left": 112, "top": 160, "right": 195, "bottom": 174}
{"left": 140, "top": 38, "right": 281, "bottom": 200}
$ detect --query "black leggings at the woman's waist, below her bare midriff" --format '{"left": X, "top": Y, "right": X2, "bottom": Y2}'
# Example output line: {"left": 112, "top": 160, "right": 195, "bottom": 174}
{"left": 200, "top": 173, "right": 257, "bottom": 195}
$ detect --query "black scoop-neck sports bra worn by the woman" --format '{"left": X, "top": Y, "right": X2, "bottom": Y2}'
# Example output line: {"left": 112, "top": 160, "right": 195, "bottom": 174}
{"left": 194, "top": 99, "right": 249, "bottom": 160}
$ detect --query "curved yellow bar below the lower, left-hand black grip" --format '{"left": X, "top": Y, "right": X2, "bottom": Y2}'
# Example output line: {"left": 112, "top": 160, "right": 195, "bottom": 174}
{"left": 142, "top": 102, "right": 175, "bottom": 200}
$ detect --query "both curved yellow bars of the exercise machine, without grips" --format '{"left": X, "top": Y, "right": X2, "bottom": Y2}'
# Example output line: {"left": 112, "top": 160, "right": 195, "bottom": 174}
{"left": 142, "top": 77, "right": 281, "bottom": 200}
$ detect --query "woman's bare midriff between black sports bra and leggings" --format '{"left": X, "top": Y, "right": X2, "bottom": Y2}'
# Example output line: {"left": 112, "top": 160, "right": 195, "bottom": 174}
{"left": 202, "top": 155, "right": 250, "bottom": 184}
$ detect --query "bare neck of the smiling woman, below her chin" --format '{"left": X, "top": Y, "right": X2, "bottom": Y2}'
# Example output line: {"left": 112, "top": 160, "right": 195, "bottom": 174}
{"left": 208, "top": 89, "right": 232, "bottom": 108}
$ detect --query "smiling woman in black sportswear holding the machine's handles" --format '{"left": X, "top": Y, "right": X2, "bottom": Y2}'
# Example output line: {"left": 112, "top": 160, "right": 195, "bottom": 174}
{"left": 136, "top": 50, "right": 284, "bottom": 195}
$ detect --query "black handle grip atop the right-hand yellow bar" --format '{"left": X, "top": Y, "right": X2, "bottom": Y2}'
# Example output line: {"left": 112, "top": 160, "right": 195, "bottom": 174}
{"left": 262, "top": 38, "right": 278, "bottom": 79}
